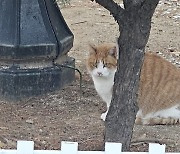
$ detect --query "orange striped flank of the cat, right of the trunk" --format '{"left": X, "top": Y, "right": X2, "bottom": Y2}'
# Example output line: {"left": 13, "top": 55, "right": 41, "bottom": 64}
{"left": 139, "top": 53, "right": 180, "bottom": 113}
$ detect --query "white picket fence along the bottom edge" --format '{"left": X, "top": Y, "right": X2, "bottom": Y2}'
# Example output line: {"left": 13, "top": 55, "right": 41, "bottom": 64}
{"left": 0, "top": 141, "right": 180, "bottom": 154}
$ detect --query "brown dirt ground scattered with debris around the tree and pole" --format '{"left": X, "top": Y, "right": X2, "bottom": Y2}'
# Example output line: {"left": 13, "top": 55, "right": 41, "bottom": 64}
{"left": 0, "top": 0, "right": 180, "bottom": 152}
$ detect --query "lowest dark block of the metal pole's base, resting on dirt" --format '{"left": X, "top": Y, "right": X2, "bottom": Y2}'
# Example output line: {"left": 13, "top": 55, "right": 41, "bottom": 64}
{"left": 0, "top": 58, "right": 75, "bottom": 101}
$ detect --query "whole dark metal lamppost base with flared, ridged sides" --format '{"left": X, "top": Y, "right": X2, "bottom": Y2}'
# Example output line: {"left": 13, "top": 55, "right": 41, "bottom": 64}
{"left": 0, "top": 0, "right": 75, "bottom": 100}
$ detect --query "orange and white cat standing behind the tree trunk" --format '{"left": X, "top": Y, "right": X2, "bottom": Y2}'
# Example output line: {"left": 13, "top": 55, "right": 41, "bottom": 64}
{"left": 87, "top": 43, "right": 180, "bottom": 125}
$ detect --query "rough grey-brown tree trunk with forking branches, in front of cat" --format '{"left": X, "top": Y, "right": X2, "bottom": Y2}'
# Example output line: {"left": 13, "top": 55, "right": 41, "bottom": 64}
{"left": 92, "top": 0, "right": 159, "bottom": 151}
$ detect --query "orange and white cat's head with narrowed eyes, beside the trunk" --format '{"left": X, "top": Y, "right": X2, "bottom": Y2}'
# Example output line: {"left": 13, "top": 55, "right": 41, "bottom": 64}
{"left": 87, "top": 43, "right": 117, "bottom": 78}
